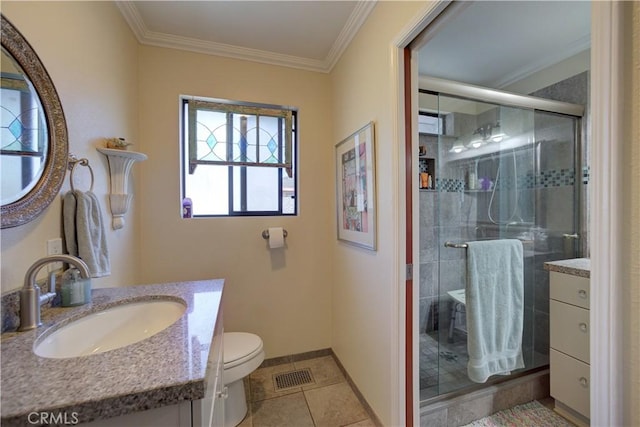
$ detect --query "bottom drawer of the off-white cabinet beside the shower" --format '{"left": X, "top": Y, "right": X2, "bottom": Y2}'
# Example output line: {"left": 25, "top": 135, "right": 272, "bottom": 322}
{"left": 549, "top": 349, "right": 591, "bottom": 418}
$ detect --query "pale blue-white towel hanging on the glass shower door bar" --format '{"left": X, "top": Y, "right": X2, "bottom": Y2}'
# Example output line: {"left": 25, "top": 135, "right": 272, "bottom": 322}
{"left": 466, "top": 239, "right": 524, "bottom": 383}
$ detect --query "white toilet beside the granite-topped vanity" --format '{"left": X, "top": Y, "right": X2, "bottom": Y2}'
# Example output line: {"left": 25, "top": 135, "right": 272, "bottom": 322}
{"left": 223, "top": 332, "right": 264, "bottom": 427}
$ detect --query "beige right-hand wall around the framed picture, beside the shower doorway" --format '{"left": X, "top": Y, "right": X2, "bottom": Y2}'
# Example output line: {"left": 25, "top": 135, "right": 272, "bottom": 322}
{"left": 331, "top": 2, "right": 425, "bottom": 425}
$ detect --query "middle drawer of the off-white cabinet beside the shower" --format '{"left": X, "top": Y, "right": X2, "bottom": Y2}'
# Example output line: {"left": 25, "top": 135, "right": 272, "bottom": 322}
{"left": 549, "top": 300, "right": 591, "bottom": 363}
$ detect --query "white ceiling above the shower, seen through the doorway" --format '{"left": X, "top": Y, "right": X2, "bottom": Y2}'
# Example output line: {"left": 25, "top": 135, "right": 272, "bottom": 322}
{"left": 418, "top": 1, "right": 591, "bottom": 88}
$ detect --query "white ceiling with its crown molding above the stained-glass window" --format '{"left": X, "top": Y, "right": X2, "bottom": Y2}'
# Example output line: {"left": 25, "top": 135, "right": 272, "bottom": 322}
{"left": 116, "top": 0, "right": 376, "bottom": 72}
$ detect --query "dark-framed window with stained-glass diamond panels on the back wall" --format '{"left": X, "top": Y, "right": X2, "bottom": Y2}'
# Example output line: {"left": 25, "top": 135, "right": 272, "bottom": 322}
{"left": 182, "top": 98, "right": 297, "bottom": 217}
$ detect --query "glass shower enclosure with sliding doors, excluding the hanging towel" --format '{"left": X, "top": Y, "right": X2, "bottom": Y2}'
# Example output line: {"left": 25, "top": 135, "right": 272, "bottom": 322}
{"left": 418, "top": 78, "right": 583, "bottom": 401}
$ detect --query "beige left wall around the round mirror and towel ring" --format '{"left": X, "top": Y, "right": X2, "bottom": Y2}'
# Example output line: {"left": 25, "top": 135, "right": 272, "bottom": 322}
{"left": 0, "top": 1, "right": 138, "bottom": 292}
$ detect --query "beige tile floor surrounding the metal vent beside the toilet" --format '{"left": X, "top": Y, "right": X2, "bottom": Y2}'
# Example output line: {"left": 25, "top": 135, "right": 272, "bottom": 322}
{"left": 240, "top": 355, "right": 376, "bottom": 427}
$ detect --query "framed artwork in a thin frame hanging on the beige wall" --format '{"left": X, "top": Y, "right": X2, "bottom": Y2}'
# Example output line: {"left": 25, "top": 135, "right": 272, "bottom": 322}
{"left": 335, "top": 122, "right": 377, "bottom": 251}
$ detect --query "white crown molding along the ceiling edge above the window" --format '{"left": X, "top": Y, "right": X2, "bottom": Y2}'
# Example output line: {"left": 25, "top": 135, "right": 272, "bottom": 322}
{"left": 116, "top": 0, "right": 377, "bottom": 73}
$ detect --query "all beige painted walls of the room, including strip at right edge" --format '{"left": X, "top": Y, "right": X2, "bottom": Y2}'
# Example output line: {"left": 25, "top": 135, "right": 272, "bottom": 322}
{"left": 0, "top": 1, "right": 640, "bottom": 425}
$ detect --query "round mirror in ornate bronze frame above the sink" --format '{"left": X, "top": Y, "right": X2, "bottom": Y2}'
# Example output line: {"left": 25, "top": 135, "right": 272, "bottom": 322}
{"left": 0, "top": 16, "right": 69, "bottom": 228}
